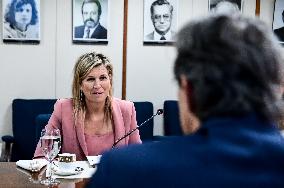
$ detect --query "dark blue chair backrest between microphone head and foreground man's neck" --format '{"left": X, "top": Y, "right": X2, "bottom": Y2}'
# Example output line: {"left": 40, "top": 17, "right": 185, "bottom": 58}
{"left": 164, "top": 100, "right": 182, "bottom": 136}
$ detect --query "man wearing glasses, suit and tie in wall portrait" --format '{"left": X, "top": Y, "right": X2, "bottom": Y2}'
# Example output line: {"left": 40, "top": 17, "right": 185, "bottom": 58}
{"left": 144, "top": 0, "right": 175, "bottom": 42}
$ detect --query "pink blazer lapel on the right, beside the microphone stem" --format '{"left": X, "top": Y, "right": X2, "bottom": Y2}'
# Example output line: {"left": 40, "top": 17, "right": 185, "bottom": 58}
{"left": 112, "top": 99, "right": 126, "bottom": 146}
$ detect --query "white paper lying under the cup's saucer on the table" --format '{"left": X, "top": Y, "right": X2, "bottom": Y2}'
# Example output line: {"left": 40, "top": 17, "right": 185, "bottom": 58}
{"left": 53, "top": 161, "right": 96, "bottom": 179}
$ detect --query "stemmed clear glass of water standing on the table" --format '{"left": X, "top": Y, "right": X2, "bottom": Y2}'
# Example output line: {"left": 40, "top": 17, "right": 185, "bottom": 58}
{"left": 40, "top": 128, "right": 61, "bottom": 186}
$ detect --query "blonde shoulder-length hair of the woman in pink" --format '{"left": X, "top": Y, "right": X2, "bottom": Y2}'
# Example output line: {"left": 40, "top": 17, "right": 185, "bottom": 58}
{"left": 72, "top": 52, "right": 113, "bottom": 120}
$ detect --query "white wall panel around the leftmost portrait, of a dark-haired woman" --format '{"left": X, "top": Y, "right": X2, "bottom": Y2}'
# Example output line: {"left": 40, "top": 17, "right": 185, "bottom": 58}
{"left": 0, "top": 0, "right": 56, "bottom": 136}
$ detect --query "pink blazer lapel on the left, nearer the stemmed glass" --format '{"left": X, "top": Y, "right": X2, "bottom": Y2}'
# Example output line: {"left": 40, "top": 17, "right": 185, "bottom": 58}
{"left": 75, "top": 111, "right": 88, "bottom": 156}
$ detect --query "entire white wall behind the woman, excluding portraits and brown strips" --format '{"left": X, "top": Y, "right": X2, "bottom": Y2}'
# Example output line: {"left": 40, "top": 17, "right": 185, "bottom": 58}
{"left": 0, "top": 0, "right": 274, "bottom": 136}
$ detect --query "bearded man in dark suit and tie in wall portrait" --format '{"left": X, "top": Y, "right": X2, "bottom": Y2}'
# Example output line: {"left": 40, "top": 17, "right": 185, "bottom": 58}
{"left": 74, "top": 0, "right": 107, "bottom": 39}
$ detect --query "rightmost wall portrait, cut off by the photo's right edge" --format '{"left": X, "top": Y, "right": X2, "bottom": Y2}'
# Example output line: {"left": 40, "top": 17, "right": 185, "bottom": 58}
{"left": 272, "top": 0, "right": 284, "bottom": 43}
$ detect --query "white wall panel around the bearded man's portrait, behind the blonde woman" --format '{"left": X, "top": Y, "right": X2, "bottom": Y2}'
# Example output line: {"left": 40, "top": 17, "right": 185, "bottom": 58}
{"left": 54, "top": 0, "right": 123, "bottom": 98}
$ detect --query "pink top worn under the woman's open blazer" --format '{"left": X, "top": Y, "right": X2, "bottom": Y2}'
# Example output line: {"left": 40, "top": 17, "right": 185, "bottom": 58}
{"left": 85, "top": 132, "right": 114, "bottom": 156}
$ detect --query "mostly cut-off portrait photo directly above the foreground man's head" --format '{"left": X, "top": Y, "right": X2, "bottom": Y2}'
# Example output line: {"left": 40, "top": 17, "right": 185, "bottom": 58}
{"left": 209, "top": 0, "right": 243, "bottom": 14}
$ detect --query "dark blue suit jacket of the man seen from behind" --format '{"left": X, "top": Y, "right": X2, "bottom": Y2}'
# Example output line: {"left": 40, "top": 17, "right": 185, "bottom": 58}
{"left": 88, "top": 116, "right": 284, "bottom": 188}
